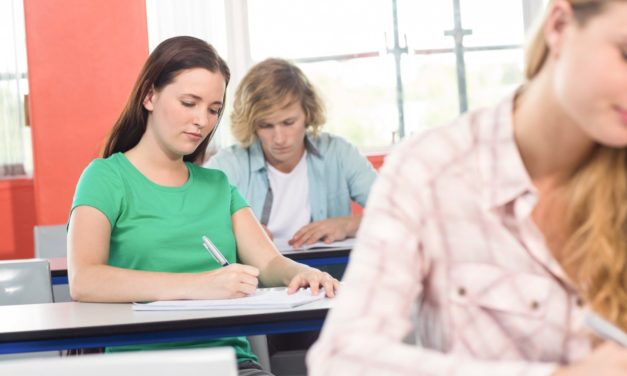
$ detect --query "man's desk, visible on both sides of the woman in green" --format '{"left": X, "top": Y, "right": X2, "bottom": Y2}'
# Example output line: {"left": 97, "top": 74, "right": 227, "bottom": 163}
{"left": 48, "top": 247, "right": 351, "bottom": 285}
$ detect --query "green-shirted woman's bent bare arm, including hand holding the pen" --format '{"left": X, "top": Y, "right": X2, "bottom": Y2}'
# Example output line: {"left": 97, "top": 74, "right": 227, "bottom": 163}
{"left": 68, "top": 206, "right": 259, "bottom": 302}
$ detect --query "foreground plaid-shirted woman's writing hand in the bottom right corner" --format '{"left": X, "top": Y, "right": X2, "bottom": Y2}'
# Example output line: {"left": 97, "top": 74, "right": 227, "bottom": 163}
{"left": 553, "top": 342, "right": 627, "bottom": 376}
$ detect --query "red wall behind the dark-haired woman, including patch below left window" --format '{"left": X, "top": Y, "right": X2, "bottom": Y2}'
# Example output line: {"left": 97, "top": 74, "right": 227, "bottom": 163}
{"left": 0, "top": 0, "right": 148, "bottom": 259}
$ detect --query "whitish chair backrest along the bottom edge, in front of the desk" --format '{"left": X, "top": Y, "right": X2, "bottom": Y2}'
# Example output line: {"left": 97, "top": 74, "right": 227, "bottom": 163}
{"left": 0, "top": 347, "right": 237, "bottom": 376}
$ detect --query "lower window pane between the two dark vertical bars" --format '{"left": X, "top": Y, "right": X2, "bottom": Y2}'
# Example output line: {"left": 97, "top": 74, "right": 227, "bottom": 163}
{"left": 403, "top": 53, "right": 459, "bottom": 135}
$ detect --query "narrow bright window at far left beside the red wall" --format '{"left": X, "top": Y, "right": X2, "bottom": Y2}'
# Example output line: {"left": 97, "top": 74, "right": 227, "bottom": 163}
{"left": 0, "top": 0, "right": 32, "bottom": 178}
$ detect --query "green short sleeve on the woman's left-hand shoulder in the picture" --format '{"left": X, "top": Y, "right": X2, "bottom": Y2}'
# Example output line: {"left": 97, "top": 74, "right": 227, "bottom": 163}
{"left": 70, "top": 159, "right": 124, "bottom": 227}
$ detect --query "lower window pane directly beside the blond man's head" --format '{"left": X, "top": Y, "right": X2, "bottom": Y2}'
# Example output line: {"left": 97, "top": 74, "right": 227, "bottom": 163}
{"left": 299, "top": 57, "right": 398, "bottom": 147}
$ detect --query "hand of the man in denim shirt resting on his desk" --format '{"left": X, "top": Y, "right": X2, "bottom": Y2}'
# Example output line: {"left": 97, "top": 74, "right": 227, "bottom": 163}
{"left": 288, "top": 216, "right": 361, "bottom": 248}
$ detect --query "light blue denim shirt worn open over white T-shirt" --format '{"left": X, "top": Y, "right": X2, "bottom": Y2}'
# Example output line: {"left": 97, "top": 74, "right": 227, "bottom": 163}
{"left": 205, "top": 133, "right": 377, "bottom": 224}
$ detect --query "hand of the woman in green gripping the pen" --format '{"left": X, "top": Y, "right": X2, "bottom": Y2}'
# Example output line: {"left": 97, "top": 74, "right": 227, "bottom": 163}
{"left": 200, "top": 264, "right": 259, "bottom": 299}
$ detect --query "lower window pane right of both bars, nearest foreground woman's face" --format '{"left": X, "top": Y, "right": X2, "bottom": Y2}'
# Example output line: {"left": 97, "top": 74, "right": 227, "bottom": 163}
{"left": 465, "top": 49, "right": 523, "bottom": 109}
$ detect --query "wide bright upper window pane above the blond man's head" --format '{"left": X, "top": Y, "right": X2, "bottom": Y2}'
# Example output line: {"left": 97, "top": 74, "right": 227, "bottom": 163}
{"left": 248, "top": 0, "right": 392, "bottom": 61}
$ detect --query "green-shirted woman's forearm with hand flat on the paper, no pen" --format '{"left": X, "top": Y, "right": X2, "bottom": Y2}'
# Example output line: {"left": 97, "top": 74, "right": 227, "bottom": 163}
{"left": 232, "top": 208, "right": 339, "bottom": 297}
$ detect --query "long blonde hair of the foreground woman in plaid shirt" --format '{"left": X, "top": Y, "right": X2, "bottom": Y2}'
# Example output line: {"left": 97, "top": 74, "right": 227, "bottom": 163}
{"left": 525, "top": 0, "right": 627, "bottom": 330}
